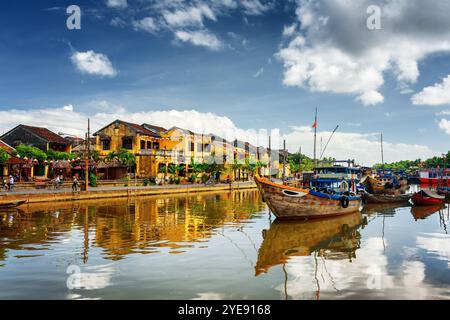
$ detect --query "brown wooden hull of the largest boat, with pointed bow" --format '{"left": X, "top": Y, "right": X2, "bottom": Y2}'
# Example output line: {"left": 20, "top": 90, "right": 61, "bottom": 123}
{"left": 255, "top": 176, "right": 361, "bottom": 219}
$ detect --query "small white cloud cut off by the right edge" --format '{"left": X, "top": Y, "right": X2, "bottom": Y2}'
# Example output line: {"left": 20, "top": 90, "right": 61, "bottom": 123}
{"left": 411, "top": 75, "right": 450, "bottom": 106}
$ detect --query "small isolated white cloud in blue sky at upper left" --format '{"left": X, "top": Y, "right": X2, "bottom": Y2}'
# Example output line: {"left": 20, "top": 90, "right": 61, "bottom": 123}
{"left": 71, "top": 50, "right": 117, "bottom": 77}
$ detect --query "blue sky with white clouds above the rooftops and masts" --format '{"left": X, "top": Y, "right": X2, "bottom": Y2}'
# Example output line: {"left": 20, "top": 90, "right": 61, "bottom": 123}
{"left": 0, "top": 0, "right": 450, "bottom": 165}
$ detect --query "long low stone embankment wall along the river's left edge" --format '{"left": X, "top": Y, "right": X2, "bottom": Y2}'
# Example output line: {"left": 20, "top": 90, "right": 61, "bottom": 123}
{"left": 0, "top": 182, "right": 256, "bottom": 205}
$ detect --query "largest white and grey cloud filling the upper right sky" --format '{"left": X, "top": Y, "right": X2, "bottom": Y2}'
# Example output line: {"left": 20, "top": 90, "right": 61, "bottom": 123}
{"left": 277, "top": 0, "right": 450, "bottom": 105}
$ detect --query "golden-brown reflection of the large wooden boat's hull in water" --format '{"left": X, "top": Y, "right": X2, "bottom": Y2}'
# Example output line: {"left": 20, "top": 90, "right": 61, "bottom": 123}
{"left": 255, "top": 212, "right": 363, "bottom": 276}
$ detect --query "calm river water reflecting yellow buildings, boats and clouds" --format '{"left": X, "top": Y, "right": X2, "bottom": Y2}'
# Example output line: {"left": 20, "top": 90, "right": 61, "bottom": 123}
{"left": 0, "top": 191, "right": 450, "bottom": 300}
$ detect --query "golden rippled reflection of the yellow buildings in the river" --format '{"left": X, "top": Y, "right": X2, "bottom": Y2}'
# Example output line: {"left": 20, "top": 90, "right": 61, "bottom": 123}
{"left": 0, "top": 191, "right": 264, "bottom": 263}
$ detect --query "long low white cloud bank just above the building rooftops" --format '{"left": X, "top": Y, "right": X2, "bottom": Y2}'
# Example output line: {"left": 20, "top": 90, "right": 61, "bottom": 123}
{"left": 0, "top": 105, "right": 440, "bottom": 165}
